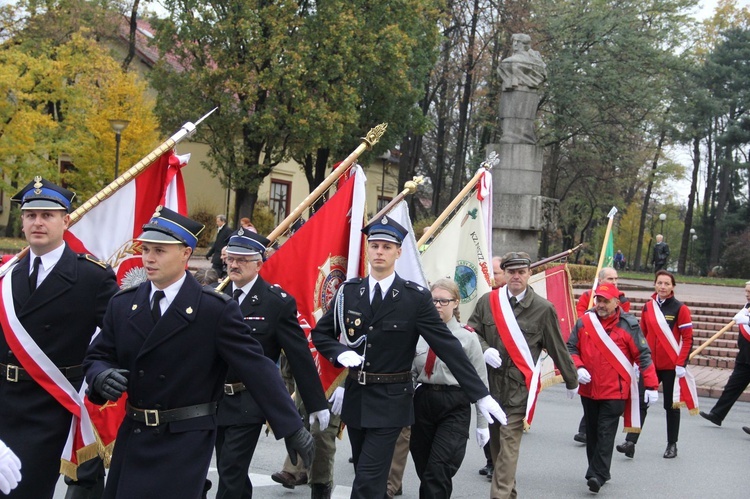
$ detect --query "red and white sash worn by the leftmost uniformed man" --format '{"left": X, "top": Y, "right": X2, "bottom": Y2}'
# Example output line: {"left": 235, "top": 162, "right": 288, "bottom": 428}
{"left": 0, "top": 271, "right": 97, "bottom": 478}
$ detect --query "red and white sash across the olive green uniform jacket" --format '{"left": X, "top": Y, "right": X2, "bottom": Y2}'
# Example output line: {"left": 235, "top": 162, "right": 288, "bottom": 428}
{"left": 490, "top": 286, "right": 542, "bottom": 429}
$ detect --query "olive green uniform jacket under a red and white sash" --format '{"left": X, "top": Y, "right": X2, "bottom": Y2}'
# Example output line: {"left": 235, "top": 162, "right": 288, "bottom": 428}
{"left": 469, "top": 286, "right": 578, "bottom": 414}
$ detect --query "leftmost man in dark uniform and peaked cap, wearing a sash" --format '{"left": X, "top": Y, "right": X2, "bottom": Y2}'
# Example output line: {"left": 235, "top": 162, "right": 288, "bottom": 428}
{"left": 0, "top": 177, "right": 118, "bottom": 499}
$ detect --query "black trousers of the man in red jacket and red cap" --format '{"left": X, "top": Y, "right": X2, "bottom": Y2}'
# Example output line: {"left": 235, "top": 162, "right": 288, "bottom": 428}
{"left": 581, "top": 397, "right": 625, "bottom": 483}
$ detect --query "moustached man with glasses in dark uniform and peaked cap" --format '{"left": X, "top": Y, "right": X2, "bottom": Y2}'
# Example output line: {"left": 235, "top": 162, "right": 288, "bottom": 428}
{"left": 216, "top": 229, "right": 330, "bottom": 499}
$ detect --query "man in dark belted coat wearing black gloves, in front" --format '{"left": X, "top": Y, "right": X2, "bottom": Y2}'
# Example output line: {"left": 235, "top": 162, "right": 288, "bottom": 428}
{"left": 84, "top": 208, "right": 313, "bottom": 499}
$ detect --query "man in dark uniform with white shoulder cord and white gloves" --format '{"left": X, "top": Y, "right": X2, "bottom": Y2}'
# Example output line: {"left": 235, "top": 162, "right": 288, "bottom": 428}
{"left": 312, "top": 216, "right": 505, "bottom": 499}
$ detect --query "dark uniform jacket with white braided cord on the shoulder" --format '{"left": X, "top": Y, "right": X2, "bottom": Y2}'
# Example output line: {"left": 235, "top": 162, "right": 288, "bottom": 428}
{"left": 312, "top": 275, "right": 488, "bottom": 428}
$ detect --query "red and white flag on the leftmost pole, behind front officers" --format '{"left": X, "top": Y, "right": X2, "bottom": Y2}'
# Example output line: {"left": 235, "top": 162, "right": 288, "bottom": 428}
{"left": 61, "top": 150, "right": 190, "bottom": 472}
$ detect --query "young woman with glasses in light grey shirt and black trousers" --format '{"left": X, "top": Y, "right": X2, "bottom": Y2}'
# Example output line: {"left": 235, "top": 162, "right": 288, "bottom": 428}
{"left": 409, "top": 279, "right": 490, "bottom": 498}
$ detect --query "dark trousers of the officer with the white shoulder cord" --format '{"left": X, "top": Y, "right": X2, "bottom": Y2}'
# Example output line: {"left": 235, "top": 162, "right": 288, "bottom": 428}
{"left": 347, "top": 426, "right": 402, "bottom": 499}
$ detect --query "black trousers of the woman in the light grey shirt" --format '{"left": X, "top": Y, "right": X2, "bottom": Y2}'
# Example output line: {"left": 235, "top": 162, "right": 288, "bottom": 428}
{"left": 409, "top": 384, "right": 471, "bottom": 499}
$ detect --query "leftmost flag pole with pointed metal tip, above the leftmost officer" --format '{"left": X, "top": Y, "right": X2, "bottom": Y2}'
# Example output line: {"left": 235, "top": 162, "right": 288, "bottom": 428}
{"left": 0, "top": 107, "right": 218, "bottom": 278}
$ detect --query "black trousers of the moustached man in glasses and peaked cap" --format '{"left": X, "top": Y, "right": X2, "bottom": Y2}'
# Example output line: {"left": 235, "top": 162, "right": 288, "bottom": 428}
{"left": 216, "top": 423, "right": 263, "bottom": 499}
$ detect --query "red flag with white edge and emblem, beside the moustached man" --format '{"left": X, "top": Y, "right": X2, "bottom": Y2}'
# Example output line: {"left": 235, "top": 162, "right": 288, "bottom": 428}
{"left": 260, "top": 165, "right": 365, "bottom": 396}
